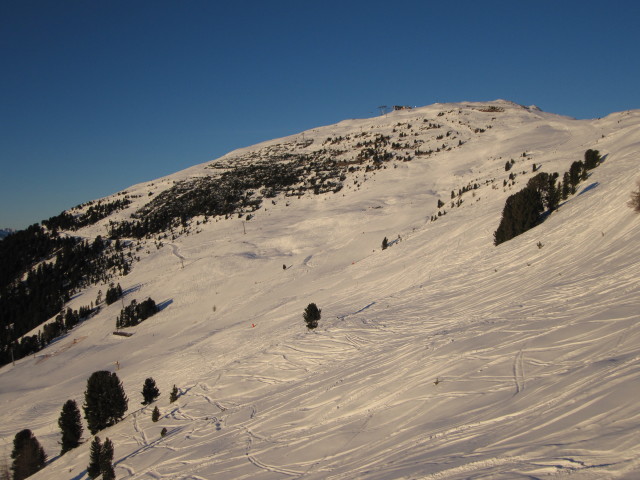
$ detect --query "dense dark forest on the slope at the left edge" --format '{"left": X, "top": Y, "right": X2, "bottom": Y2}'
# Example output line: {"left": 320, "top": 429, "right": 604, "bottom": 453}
{"left": 0, "top": 229, "right": 132, "bottom": 365}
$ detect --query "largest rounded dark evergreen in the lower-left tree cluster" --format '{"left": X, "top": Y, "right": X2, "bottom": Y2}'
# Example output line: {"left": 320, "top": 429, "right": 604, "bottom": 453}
{"left": 83, "top": 370, "right": 129, "bottom": 435}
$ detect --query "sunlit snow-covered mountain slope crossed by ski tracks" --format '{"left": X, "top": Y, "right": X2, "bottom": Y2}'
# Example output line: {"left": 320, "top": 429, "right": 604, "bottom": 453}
{"left": 0, "top": 101, "right": 640, "bottom": 480}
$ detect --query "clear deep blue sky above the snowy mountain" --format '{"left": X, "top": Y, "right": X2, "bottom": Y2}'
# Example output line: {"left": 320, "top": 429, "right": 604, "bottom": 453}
{"left": 0, "top": 0, "right": 640, "bottom": 228}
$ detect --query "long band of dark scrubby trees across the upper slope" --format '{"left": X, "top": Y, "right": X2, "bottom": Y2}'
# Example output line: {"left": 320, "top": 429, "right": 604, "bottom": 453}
{"left": 109, "top": 146, "right": 395, "bottom": 238}
